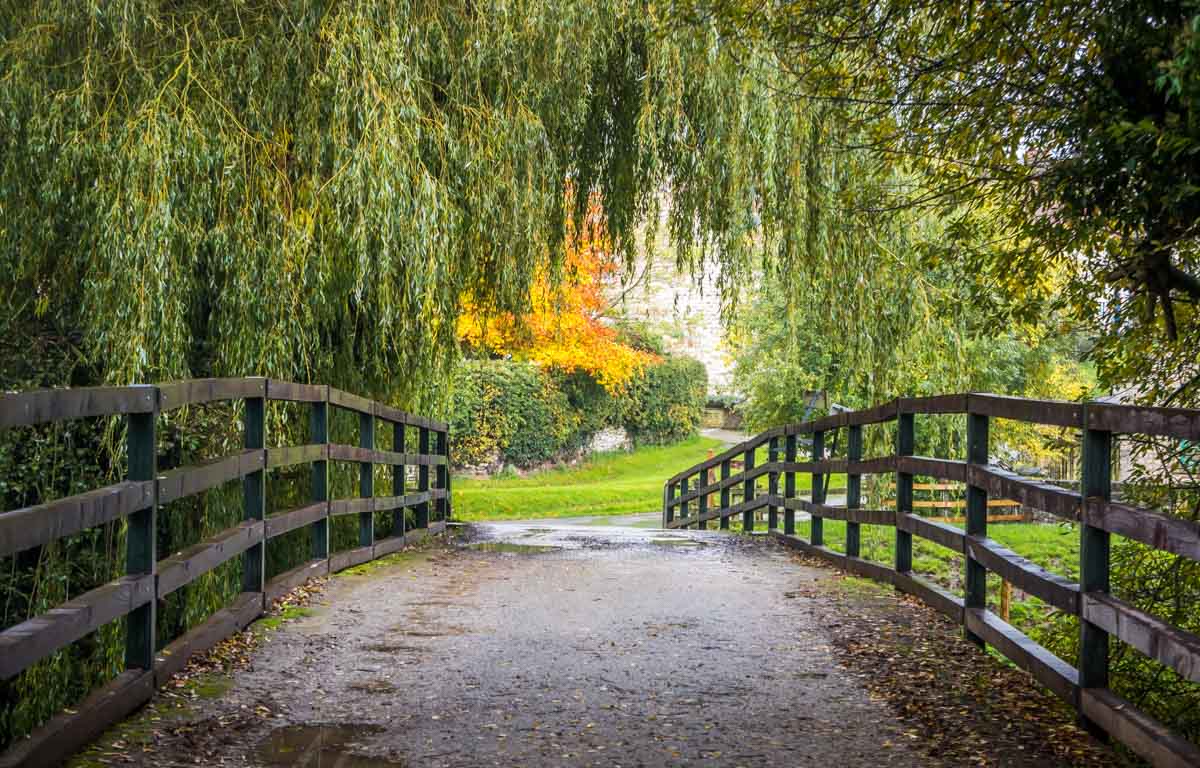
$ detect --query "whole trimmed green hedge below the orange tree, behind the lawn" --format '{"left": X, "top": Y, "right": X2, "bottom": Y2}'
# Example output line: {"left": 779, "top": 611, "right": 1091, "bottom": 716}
{"left": 450, "top": 358, "right": 708, "bottom": 467}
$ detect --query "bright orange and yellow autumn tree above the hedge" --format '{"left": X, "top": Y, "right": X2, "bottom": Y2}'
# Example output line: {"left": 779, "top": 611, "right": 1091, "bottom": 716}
{"left": 458, "top": 198, "right": 659, "bottom": 394}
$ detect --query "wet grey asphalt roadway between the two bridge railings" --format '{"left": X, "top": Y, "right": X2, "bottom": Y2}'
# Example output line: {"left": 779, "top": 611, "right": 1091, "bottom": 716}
{"left": 126, "top": 523, "right": 928, "bottom": 768}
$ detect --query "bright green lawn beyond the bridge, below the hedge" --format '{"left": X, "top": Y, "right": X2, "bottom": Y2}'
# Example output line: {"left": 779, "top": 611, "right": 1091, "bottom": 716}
{"left": 454, "top": 437, "right": 846, "bottom": 521}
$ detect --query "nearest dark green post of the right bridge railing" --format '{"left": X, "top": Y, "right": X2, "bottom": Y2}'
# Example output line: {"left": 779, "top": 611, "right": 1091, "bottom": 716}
{"left": 1079, "top": 406, "right": 1112, "bottom": 734}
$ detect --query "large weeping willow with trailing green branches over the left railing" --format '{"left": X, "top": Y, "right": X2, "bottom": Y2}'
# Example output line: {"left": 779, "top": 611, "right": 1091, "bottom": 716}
{"left": 0, "top": 0, "right": 864, "bottom": 743}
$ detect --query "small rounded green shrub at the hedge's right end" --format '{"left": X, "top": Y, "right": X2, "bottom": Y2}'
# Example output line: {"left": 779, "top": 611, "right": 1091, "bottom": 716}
{"left": 625, "top": 356, "right": 708, "bottom": 445}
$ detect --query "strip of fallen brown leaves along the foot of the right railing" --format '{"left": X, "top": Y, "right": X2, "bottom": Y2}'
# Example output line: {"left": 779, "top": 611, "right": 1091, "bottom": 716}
{"left": 792, "top": 558, "right": 1126, "bottom": 768}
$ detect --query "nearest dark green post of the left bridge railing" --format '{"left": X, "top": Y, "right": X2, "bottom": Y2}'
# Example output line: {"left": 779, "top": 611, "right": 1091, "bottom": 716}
{"left": 125, "top": 388, "right": 158, "bottom": 670}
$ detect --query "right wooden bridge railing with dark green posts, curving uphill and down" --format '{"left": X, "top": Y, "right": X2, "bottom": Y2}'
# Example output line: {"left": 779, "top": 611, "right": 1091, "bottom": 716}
{"left": 662, "top": 394, "right": 1200, "bottom": 766}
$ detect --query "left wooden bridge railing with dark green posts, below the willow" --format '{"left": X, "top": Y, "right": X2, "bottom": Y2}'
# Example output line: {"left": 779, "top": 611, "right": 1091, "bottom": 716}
{"left": 0, "top": 378, "right": 450, "bottom": 768}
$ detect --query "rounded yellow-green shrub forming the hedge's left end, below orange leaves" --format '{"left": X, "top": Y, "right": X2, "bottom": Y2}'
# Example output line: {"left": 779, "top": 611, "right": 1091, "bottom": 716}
{"left": 450, "top": 360, "right": 581, "bottom": 467}
